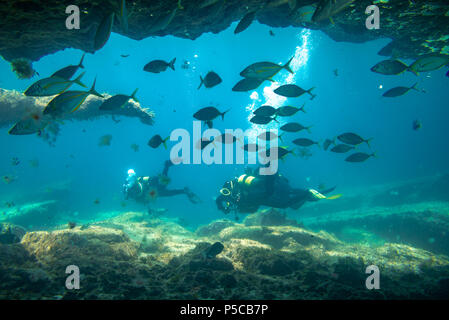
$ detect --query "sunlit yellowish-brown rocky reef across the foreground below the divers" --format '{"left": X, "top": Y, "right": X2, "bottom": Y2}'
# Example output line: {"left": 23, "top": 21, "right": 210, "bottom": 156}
{"left": 0, "top": 208, "right": 449, "bottom": 299}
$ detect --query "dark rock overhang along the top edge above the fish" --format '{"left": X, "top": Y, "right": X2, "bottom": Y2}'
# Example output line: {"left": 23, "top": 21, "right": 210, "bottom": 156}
{"left": 0, "top": 0, "right": 449, "bottom": 61}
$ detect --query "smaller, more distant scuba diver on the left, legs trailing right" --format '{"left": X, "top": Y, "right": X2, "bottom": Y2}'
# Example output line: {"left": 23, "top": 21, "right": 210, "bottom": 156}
{"left": 123, "top": 160, "right": 200, "bottom": 204}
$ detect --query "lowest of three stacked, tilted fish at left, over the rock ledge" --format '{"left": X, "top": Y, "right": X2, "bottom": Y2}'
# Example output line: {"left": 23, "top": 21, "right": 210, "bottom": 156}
{"left": 43, "top": 80, "right": 103, "bottom": 118}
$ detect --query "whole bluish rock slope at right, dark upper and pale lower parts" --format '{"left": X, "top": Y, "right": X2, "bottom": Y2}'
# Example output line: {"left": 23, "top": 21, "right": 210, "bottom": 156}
{"left": 301, "top": 174, "right": 449, "bottom": 255}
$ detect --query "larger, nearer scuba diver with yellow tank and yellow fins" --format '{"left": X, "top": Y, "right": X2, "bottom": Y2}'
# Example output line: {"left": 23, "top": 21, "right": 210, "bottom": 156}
{"left": 216, "top": 170, "right": 341, "bottom": 214}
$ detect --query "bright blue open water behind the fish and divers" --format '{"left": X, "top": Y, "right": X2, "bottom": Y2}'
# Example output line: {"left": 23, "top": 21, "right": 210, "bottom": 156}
{"left": 0, "top": 23, "right": 449, "bottom": 225}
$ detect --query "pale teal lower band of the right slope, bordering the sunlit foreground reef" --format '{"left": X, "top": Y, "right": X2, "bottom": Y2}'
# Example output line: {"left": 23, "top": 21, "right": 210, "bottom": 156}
{"left": 303, "top": 202, "right": 449, "bottom": 255}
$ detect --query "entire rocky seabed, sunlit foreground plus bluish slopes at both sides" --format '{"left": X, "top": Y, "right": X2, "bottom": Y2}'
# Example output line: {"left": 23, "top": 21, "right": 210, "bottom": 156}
{"left": 0, "top": 175, "right": 449, "bottom": 299}
